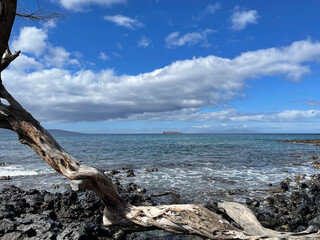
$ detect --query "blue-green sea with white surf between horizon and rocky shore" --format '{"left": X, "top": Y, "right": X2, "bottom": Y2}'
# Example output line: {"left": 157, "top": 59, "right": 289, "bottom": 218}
{"left": 0, "top": 134, "right": 320, "bottom": 203}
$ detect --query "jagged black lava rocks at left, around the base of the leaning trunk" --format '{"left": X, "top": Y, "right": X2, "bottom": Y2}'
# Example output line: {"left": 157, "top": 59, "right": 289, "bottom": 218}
{"left": 0, "top": 169, "right": 195, "bottom": 240}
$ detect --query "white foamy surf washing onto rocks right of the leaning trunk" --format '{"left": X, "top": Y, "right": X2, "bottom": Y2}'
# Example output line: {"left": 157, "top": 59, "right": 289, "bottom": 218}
{"left": 130, "top": 161, "right": 315, "bottom": 202}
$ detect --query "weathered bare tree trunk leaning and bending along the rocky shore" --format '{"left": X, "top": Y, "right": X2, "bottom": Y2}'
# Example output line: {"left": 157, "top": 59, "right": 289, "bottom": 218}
{"left": 0, "top": 0, "right": 320, "bottom": 239}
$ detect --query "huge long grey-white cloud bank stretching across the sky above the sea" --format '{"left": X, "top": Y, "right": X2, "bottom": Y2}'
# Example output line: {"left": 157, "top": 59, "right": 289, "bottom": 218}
{"left": 3, "top": 40, "right": 320, "bottom": 121}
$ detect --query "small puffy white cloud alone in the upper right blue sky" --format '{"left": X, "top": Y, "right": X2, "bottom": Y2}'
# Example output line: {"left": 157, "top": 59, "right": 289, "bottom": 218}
{"left": 231, "top": 6, "right": 259, "bottom": 31}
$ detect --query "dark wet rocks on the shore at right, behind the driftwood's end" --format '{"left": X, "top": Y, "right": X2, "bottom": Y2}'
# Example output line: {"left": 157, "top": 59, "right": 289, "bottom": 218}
{"left": 246, "top": 174, "right": 320, "bottom": 232}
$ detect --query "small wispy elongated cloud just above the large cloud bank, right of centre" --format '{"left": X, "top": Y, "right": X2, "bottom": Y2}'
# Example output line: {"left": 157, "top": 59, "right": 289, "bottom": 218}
{"left": 165, "top": 29, "right": 213, "bottom": 48}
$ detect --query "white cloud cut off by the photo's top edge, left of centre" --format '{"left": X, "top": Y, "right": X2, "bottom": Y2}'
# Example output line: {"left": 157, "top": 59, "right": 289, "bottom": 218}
{"left": 59, "top": 0, "right": 127, "bottom": 11}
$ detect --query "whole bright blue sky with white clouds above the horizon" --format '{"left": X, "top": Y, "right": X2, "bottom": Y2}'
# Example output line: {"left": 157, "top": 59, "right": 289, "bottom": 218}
{"left": 2, "top": 0, "right": 320, "bottom": 133}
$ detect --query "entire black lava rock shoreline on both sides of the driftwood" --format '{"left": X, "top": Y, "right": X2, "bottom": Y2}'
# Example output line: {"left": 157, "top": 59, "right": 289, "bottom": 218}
{"left": 0, "top": 163, "right": 320, "bottom": 240}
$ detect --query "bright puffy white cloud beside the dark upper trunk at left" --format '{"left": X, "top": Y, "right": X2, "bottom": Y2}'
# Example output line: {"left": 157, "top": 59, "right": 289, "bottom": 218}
{"left": 12, "top": 27, "right": 48, "bottom": 56}
